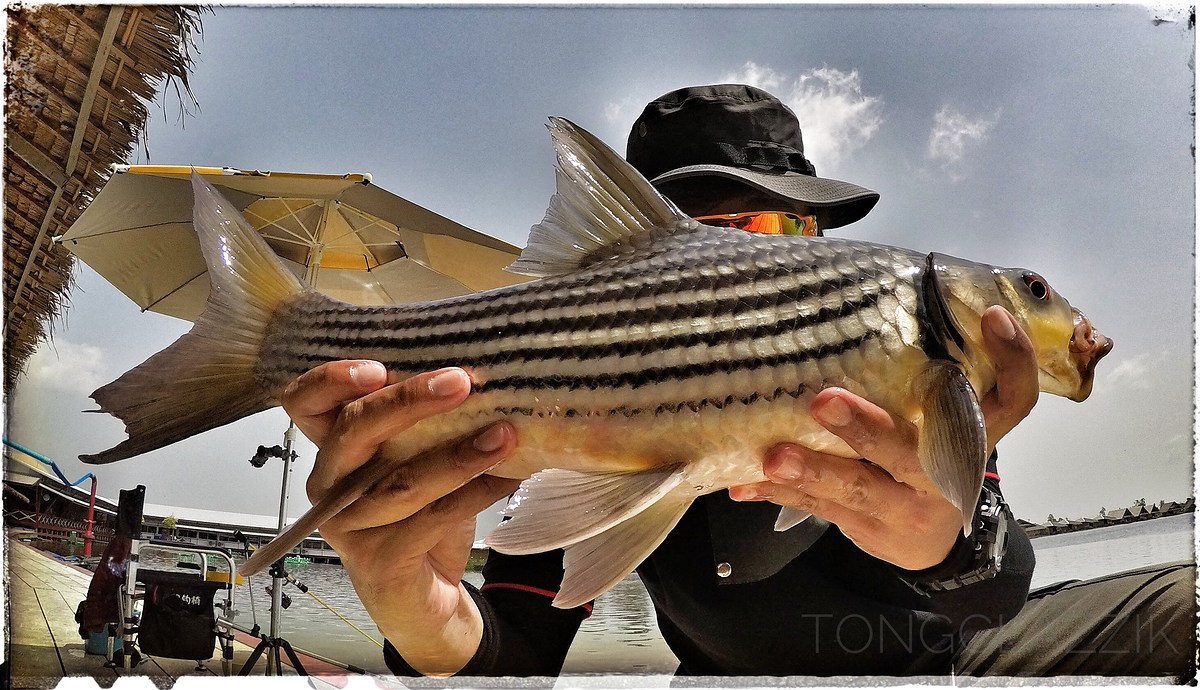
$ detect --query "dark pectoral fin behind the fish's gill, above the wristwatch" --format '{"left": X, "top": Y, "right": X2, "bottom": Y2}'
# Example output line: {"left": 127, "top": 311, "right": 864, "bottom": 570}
{"left": 914, "top": 361, "right": 988, "bottom": 536}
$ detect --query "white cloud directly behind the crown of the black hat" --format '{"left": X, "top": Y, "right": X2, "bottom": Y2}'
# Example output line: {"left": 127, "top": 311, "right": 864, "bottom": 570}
{"left": 722, "top": 62, "right": 883, "bottom": 175}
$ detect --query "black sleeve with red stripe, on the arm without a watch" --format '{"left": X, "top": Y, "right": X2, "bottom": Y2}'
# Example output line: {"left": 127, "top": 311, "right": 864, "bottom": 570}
{"left": 384, "top": 550, "right": 592, "bottom": 676}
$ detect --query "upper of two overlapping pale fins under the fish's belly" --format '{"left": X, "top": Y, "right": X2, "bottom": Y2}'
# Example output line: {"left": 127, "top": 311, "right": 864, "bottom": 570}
{"left": 485, "top": 466, "right": 683, "bottom": 554}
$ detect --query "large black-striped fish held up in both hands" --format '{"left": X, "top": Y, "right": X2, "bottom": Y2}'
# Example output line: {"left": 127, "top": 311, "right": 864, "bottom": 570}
{"left": 87, "top": 118, "right": 1112, "bottom": 608}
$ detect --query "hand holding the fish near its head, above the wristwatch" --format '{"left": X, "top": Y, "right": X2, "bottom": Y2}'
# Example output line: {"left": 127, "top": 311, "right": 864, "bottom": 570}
{"left": 730, "top": 307, "right": 1039, "bottom": 570}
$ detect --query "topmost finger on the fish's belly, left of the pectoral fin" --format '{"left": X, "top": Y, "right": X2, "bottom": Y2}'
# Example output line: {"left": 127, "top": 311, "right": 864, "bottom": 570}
{"left": 810, "top": 388, "right": 932, "bottom": 488}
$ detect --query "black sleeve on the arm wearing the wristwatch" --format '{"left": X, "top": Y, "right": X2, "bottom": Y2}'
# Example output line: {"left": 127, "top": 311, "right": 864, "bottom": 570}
{"left": 902, "top": 451, "right": 1034, "bottom": 632}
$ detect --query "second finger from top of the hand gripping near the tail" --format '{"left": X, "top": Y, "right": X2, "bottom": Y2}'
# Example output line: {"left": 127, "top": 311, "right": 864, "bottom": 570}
{"left": 308, "top": 367, "right": 470, "bottom": 502}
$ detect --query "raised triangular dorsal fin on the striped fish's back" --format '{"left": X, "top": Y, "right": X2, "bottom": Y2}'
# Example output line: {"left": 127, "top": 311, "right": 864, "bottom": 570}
{"left": 508, "top": 118, "right": 698, "bottom": 277}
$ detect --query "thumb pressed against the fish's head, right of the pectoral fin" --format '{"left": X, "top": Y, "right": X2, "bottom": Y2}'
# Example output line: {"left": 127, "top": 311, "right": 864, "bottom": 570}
{"left": 980, "top": 306, "right": 1039, "bottom": 445}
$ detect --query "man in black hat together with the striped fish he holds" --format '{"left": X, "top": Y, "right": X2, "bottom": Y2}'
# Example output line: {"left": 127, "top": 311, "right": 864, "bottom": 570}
{"left": 80, "top": 85, "right": 1195, "bottom": 677}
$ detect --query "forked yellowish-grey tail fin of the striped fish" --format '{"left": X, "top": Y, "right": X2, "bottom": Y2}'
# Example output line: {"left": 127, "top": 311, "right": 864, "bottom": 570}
{"left": 79, "top": 173, "right": 305, "bottom": 464}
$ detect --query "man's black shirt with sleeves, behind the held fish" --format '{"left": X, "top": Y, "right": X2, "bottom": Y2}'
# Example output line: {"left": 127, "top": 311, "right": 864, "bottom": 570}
{"left": 385, "top": 456, "right": 1033, "bottom": 676}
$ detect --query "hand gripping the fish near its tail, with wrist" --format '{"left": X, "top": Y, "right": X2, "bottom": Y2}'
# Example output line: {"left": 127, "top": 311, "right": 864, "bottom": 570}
{"left": 283, "top": 360, "right": 518, "bottom": 674}
